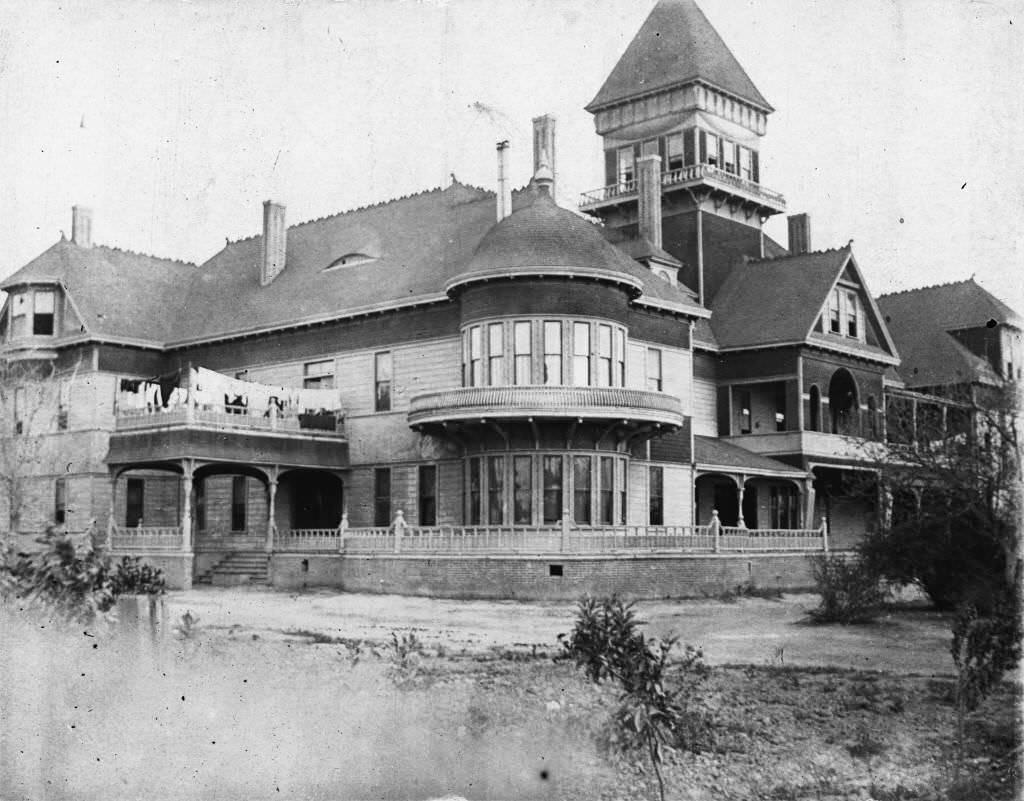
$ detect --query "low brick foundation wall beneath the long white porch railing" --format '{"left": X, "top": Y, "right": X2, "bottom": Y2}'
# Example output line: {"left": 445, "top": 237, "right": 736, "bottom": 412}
{"left": 270, "top": 554, "right": 814, "bottom": 600}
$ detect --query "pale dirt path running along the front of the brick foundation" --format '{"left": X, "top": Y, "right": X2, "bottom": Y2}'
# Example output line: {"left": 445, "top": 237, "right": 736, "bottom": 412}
{"left": 168, "top": 588, "right": 952, "bottom": 675}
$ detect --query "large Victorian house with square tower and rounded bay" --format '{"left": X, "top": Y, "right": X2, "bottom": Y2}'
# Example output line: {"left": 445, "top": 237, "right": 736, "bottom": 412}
{"left": 0, "top": 0, "right": 1021, "bottom": 595}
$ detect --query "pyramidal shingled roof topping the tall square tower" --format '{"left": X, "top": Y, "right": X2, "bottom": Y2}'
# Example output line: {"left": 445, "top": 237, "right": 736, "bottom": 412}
{"left": 587, "top": 0, "right": 774, "bottom": 112}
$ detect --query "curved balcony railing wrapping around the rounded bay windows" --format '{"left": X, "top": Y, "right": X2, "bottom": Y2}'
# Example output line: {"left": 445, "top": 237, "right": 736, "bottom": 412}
{"left": 409, "top": 386, "right": 683, "bottom": 426}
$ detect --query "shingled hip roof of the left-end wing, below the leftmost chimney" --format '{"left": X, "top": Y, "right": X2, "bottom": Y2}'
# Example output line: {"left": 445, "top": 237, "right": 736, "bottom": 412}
{"left": 0, "top": 239, "right": 196, "bottom": 344}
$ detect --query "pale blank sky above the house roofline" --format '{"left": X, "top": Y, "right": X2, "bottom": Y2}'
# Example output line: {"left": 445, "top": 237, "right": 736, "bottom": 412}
{"left": 0, "top": 0, "right": 1024, "bottom": 311}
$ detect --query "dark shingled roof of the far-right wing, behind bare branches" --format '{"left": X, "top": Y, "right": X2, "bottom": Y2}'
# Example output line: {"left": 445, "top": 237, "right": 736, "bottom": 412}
{"left": 878, "top": 279, "right": 1024, "bottom": 387}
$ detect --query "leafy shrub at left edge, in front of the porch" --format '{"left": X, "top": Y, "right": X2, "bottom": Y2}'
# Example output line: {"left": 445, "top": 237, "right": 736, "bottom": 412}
{"left": 0, "top": 529, "right": 164, "bottom": 623}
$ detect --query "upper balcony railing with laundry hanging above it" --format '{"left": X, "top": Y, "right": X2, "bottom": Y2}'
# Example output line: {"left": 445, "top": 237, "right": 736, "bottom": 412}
{"left": 115, "top": 405, "right": 345, "bottom": 436}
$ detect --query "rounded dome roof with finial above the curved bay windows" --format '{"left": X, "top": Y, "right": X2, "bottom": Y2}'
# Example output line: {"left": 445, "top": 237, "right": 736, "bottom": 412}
{"left": 446, "top": 191, "right": 643, "bottom": 296}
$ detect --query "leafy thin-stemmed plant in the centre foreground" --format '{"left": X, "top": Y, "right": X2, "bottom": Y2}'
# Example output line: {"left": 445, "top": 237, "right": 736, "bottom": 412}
{"left": 559, "top": 595, "right": 710, "bottom": 801}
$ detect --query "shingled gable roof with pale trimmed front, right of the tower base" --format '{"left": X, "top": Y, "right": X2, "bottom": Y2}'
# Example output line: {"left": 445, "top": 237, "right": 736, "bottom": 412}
{"left": 712, "top": 245, "right": 897, "bottom": 361}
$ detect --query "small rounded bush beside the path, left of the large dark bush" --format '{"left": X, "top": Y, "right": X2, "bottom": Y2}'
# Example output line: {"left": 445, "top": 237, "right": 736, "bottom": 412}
{"left": 809, "top": 554, "right": 887, "bottom": 626}
